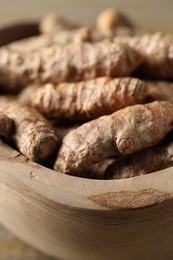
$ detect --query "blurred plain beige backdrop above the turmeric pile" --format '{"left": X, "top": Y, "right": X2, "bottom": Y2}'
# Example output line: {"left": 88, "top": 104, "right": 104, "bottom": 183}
{"left": 0, "top": 0, "right": 173, "bottom": 32}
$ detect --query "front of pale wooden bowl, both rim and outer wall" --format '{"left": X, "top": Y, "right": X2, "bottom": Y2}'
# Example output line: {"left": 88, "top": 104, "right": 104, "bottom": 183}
{"left": 0, "top": 22, "right": 173, "bottom": 260}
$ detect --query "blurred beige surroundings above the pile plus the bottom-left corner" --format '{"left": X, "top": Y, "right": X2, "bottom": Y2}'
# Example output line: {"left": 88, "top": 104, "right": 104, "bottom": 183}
{"left": 0, "top": 0, "right": 173, "bottom": 260}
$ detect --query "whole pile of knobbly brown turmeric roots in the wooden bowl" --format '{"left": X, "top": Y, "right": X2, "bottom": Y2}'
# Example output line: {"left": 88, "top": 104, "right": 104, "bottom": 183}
{"left": 0, "top": 9, "right": 173, "bottom": 179}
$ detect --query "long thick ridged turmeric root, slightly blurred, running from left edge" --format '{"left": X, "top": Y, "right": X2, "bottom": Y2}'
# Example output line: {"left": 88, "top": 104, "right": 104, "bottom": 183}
{"left": 0, "top": 42, "right": 141, "bottom": 92}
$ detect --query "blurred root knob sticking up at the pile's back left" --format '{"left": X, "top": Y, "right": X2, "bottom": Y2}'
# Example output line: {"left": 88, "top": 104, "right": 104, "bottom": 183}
{"left": 39, "top": 13, "right": 80, "bottom": 34}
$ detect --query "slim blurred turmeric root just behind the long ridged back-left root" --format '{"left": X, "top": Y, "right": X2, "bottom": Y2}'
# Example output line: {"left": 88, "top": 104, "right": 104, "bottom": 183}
{"left": 5, "top": 27, "right": 91, "bottom": 53}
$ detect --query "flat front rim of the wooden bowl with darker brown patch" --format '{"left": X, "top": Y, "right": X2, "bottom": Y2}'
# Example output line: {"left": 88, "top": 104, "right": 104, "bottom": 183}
{"left": 0, "top": 142, "right": 173, "bottom": 211}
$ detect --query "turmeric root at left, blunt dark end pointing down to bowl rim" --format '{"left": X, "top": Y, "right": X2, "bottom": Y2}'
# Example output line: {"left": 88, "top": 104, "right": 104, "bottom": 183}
{"left": 0, "top": 97, "right": 59, "bottom": 162}
